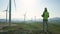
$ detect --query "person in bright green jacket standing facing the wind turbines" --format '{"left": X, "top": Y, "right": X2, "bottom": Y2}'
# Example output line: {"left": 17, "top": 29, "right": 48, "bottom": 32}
{"left": 42, "top": 8, "right": 49, "bottom": 32}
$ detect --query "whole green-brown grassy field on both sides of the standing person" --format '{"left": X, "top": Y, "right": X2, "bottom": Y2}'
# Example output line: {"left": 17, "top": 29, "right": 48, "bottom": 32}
{"left": 0, "top": 22, "right": 60, "bottom": 34}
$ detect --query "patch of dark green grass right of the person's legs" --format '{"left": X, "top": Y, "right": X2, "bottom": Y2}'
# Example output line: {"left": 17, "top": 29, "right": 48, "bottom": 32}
{"left": 49, "top": 23, "right": 60, "bottom": 34}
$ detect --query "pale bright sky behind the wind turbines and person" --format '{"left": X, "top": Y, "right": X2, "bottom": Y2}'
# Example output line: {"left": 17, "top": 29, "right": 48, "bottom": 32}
{"left": 0, "top": 0, "right": 60, "bottom": 19}
